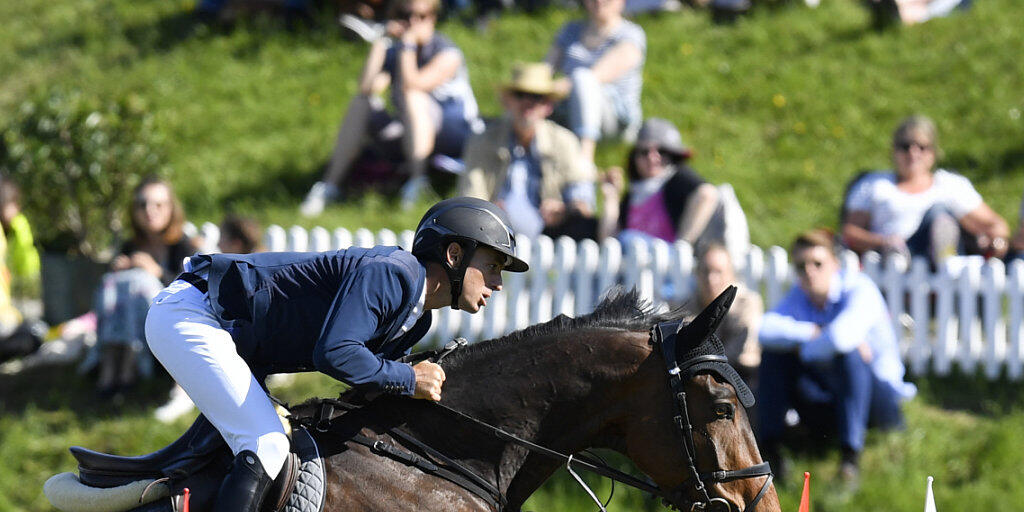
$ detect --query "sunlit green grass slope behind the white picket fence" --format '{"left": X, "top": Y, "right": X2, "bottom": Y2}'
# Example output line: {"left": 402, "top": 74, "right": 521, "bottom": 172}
{"left": 0, "top": 0, "right": 1024, "bottom": 246}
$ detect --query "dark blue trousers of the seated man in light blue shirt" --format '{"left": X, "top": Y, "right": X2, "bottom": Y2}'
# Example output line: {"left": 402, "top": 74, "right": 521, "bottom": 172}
{"left": 758, "top": 350, "right": 903, "bottom": 452}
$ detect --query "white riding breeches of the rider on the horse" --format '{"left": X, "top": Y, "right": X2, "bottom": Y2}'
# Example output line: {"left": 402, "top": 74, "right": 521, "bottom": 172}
{"left": 145, "top": 280, "right": 289, "bottom": 478}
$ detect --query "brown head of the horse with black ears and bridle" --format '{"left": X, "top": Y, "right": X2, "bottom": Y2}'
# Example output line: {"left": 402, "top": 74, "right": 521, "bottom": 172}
{"left": 627, "top": 287, "right": 779, "bottom": 512}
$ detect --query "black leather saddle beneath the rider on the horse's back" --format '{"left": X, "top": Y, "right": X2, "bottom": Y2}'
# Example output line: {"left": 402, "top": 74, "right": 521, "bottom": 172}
{"left": 71, "top": 415, "right": 311, "bottom": 512}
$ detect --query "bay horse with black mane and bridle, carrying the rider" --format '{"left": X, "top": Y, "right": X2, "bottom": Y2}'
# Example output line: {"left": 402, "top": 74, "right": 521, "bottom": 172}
{"left": 51, "top": 288, "right": 781, "bottom": 512}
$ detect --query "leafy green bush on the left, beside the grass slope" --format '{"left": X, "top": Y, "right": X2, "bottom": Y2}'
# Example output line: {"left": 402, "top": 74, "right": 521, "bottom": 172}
{"left": 0, "top": 90, "right": 166, "bottom": 258}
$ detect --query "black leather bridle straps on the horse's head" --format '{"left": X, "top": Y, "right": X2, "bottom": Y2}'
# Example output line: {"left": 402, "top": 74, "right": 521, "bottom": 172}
{"left": 651, "top": 322, "right": 773, "bottom": 512}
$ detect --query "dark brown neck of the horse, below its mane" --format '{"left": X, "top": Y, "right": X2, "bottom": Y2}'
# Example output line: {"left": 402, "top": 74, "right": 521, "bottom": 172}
{"left": 405, "top": 330, "right": 649, "bottom": 505}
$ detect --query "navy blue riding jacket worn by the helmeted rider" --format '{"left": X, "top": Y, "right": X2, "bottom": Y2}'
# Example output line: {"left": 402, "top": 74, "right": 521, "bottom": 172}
{"left": 190, "top": 247, "right": 430, "bottom": 394}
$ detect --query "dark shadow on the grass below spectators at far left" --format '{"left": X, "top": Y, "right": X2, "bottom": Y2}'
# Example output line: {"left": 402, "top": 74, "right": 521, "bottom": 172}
{"left": 0, "top": 365, "right": 171, "bottom": 419}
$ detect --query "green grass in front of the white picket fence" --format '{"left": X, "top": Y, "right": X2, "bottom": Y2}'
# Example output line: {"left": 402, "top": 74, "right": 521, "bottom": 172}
{"left": 6, "top": 367, "right": 1024, "bottom": 512}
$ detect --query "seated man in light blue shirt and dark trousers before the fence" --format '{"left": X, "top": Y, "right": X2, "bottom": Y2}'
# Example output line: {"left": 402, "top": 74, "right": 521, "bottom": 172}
{"left": 758, "top": 229, "right": 916, "bottom": 482}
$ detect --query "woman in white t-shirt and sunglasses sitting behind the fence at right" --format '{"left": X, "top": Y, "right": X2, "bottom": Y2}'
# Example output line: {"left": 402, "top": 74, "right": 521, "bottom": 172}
{"left": 843, "top": 116, "right": 1010, "bottom": 264}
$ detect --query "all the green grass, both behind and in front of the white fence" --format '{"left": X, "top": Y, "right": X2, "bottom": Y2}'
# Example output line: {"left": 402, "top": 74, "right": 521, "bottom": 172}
{"left": 0, "top": 0, "right": 1024, "bottom": 511}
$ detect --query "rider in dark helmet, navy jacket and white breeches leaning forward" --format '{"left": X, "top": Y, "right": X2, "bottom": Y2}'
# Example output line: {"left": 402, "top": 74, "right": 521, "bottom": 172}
{"left": 145, "top": 198, "right": 527, "bottom": 512}
